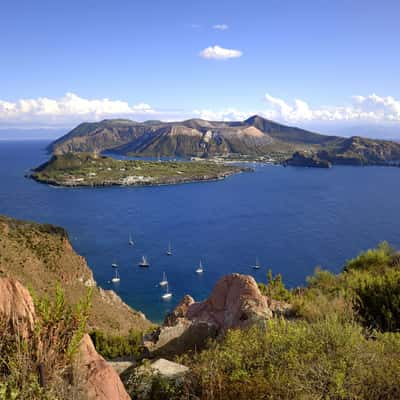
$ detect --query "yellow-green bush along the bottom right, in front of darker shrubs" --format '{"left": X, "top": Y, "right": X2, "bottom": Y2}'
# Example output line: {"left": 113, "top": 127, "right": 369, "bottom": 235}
{"left": 180, "top": 317, "right": 400, "bottom": 400}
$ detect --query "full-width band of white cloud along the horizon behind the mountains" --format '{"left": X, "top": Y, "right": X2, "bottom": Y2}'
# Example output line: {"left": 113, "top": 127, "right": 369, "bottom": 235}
{"left": 0, "top": 93, "right": 400, "bottom": 137}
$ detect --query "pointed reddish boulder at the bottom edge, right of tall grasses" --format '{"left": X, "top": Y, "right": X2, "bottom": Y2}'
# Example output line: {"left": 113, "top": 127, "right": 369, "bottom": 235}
{"left": 74, "top": 334, "right": 130, "bottom": 400}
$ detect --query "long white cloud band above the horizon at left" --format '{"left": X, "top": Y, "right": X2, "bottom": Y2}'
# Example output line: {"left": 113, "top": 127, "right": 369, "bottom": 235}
{"left": 0, "top": 93, "right": 157, "bottom": 125}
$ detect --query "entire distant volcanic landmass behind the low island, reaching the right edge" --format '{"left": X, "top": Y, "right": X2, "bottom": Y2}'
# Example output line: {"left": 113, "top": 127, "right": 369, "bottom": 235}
{"left": 48, "top": 115, "right": 400, "bottom": 164}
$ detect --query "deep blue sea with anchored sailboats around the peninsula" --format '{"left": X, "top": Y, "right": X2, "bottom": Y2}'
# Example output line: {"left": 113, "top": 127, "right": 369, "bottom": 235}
{"left": 0, "top": 141, "right": 400, "bottom": 321}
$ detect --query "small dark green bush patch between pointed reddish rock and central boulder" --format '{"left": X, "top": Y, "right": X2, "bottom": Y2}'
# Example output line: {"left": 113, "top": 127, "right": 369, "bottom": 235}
{"left": 90, "top": 330, "right": 143, "bottom": 359}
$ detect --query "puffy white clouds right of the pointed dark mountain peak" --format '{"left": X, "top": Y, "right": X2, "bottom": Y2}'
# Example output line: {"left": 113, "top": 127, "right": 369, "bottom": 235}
{"left": 264, "top": 93, "right": 400, "bottom": 123}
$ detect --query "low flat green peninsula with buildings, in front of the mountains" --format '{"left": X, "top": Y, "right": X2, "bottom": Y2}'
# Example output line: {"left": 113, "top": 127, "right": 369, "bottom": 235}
{"left": 29, "top": 153, "right": 251, "bottom": 187}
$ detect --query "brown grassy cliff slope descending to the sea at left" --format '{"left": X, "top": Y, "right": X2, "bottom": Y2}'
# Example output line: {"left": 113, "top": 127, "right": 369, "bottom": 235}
{"left": 0, "top": 216, "right": 151, "bottom": 334}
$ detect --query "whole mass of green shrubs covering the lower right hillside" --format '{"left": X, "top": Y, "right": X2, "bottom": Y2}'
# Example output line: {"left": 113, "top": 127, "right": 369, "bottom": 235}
{"left": 173, "top": 242, "right": 400, "bottom": 400}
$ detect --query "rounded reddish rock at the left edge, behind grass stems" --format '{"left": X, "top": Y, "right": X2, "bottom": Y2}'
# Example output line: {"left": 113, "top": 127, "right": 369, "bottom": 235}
{"left": 0, "top": 278, "right": 35, "bottom": 336}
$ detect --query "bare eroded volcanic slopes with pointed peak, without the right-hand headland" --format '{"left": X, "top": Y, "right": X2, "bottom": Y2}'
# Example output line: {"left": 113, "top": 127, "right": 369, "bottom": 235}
{"left": 49, "top": 116, "right": 335, "bottom": 157}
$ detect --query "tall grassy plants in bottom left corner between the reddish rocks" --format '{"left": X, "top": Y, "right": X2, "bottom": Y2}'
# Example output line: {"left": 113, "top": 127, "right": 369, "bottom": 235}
{"left": 0, "top": 286, "right": 91, "bottom": 400}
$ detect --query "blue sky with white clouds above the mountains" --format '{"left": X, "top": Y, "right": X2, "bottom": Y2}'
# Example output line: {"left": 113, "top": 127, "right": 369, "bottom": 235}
{"left": 0, "top": 0, "right": 400, "bottom": 138}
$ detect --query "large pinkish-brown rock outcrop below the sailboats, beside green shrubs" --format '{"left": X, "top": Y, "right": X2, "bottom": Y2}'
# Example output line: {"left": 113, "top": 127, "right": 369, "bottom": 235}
{"left": 144, "top": 274, "right": 272, "bottom": 356}
